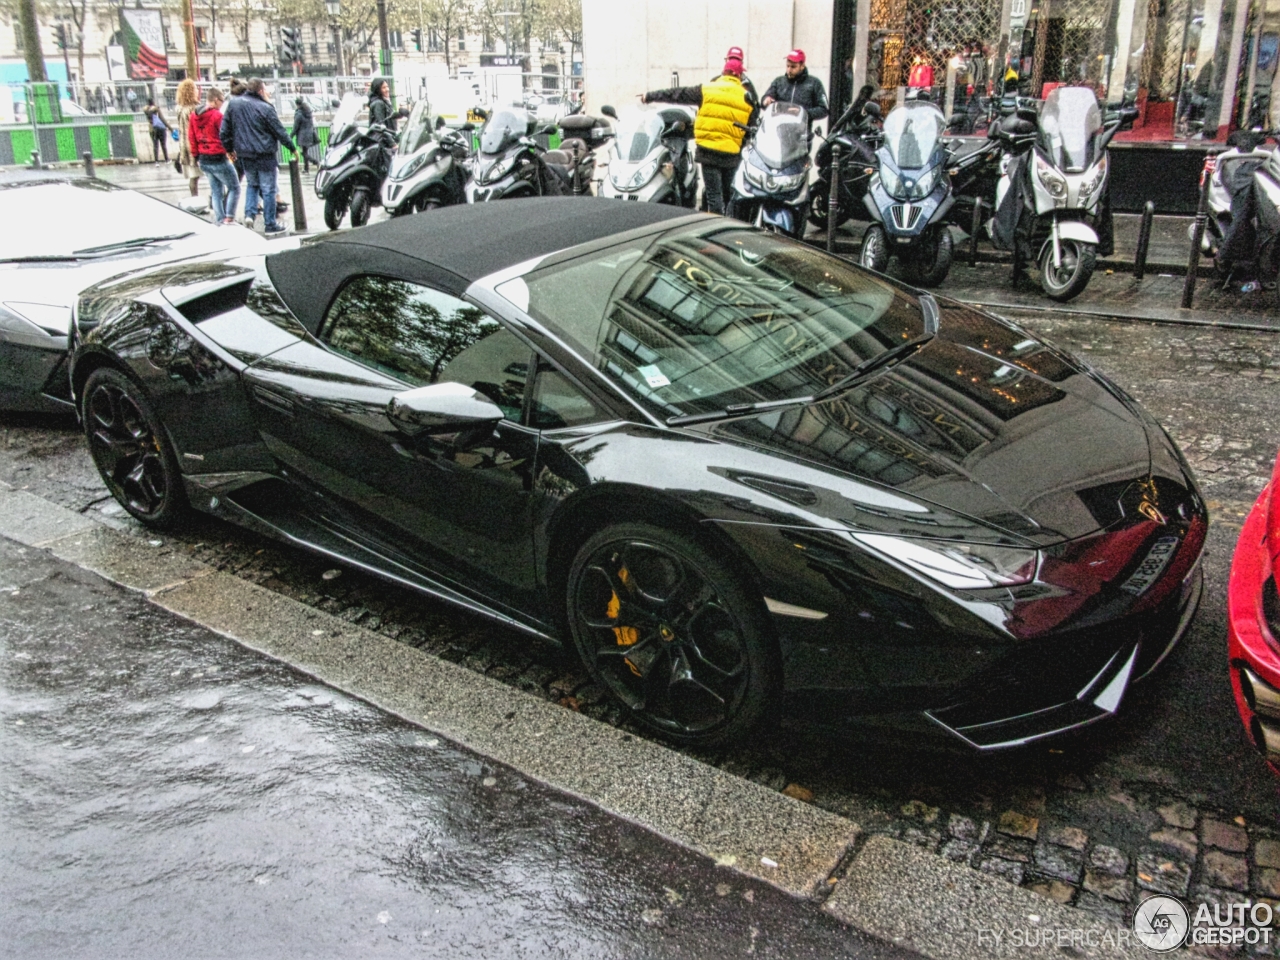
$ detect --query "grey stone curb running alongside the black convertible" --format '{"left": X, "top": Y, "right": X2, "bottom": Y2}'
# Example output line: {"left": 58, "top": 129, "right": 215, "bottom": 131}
{"left": 0, "top": 483, "right": 1139, "bottom": 960}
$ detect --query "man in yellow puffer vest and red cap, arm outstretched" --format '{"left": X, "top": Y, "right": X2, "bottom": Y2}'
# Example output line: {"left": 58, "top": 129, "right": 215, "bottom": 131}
{"left": 640, "top": 58, "right": 755, "bottom": 214}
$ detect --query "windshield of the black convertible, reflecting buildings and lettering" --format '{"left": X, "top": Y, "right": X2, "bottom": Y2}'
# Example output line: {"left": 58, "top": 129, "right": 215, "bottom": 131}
{"left": 498, "top": 220, "right": 925, "bottom": 417}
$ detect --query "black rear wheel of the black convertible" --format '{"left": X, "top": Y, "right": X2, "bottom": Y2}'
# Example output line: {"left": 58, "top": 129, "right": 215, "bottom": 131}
{"left": 82, "top": 367, "right": 188, "bottom": 527}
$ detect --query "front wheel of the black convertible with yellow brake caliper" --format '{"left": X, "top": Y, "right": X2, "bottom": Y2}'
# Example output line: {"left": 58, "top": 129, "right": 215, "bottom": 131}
{"left": 567, "top": 524, "right": 778, "bottom": 748}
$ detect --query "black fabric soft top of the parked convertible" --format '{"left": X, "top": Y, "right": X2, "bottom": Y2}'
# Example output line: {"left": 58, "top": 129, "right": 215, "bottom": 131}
{"left": 266, "top": 197, "right": 690, "bottom": 333}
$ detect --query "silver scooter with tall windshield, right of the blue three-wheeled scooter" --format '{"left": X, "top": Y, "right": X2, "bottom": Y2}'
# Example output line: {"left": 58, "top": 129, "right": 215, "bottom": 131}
{"left": 992, "top": 87, "right": 1137, "bottom": 302}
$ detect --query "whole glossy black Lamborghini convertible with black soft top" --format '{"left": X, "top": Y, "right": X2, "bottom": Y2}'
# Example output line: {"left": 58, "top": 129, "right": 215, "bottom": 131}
{"left": 70, "top": 198, "right": 1207, "bottom": 750}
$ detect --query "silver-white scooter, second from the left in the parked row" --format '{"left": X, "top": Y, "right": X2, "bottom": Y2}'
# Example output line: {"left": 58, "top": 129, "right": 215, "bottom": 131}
{"left": 383, "top": 100, "right": 474, "bottom": 216}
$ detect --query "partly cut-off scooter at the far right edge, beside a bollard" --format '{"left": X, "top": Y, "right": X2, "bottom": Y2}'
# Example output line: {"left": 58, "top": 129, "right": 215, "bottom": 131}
{"left": 1201, "top": 131, "right": 1280, "bottom": 291}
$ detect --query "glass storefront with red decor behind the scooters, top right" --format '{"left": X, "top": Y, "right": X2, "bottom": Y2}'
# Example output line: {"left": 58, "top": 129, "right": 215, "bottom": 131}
{"left": 831, "top": 0, "right": 1280, "bottom": 143}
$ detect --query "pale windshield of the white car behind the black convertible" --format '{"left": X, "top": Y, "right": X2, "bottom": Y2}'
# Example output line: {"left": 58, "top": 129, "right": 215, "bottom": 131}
{"left": 0, "top": 179, "right": 204, "bottom": 260}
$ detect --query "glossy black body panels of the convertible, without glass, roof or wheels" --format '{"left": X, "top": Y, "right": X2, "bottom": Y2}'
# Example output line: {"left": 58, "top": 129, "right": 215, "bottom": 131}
{"left": 73, "top": 211, "right": 1207, "bottom": 745}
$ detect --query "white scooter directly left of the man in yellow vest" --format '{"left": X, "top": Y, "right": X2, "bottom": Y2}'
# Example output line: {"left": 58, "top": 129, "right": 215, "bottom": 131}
{"left": 600, "top": 106, "right": 698, "bottom": 204}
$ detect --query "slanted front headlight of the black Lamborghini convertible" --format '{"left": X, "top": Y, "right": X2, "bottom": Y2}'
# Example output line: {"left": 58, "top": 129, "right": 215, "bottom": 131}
{"left": 852, "top": 534, "right": 1039, "bottom": 590}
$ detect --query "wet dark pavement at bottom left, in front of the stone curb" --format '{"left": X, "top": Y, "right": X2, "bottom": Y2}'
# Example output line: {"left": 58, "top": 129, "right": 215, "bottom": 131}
{"left": 0, "top": 540, "right": 908, "bottom": 960}
